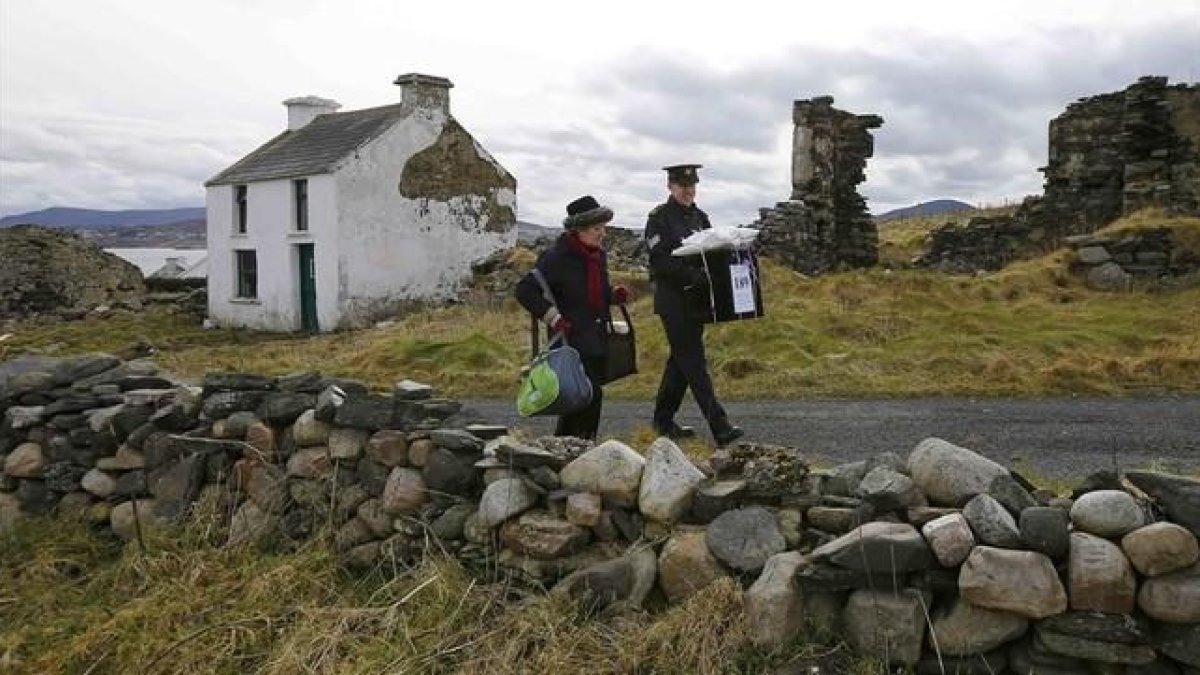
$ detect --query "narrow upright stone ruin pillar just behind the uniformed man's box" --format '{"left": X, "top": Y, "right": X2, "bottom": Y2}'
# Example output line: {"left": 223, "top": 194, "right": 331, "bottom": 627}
{"left": 750, "top": 96, "right": 883, "bottom": 274}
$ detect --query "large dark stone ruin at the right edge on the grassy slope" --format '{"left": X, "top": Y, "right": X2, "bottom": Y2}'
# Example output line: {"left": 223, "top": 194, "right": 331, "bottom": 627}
{"left": 917, "top": 77, "right": 1200, "bottom": 274}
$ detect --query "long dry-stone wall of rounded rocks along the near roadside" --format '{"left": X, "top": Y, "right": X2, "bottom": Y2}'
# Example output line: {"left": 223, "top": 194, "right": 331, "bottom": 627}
{"left": 0, "top": 354, "right": 1200, "bottom": 675}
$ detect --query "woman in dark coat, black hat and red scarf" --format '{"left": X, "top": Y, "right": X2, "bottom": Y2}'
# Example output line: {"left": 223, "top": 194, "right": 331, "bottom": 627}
{"left": 515, "top": 195, "right": 629, "bottom": 438}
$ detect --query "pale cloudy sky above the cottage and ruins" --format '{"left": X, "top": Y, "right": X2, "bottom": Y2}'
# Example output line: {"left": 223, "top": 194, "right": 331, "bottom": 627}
{"left": 0, "top": 0, "right": 1200, "bottom": 227}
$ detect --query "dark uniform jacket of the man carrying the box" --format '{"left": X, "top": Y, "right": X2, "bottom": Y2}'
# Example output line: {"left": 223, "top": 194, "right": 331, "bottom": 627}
{"left": 646, "top": 197, "right": 712, "bottom": 318}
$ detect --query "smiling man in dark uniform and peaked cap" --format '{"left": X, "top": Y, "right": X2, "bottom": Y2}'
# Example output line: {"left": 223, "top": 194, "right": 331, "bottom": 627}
{"left": 646, "top": 165, "right": 743, "bottom": 446}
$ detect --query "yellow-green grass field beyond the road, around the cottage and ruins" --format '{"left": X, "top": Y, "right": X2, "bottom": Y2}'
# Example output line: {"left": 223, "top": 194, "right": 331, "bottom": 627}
{"left": 0, "top": 212, "right": 1200, "bottom": 399}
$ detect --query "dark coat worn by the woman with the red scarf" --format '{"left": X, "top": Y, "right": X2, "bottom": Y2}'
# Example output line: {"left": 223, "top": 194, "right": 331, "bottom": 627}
{"left": 515, "top": 233, "right": 612, "bottom": 357}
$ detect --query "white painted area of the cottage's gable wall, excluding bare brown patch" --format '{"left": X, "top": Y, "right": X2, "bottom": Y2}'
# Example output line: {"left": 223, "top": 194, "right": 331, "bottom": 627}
{"left": 336, "top": 110, "right": 517, "bottom": 327}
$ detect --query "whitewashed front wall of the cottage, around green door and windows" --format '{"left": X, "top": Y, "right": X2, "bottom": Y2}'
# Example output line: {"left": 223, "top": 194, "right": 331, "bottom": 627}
{"left": 206, "top": 175, "right": 340, "bottom": 331}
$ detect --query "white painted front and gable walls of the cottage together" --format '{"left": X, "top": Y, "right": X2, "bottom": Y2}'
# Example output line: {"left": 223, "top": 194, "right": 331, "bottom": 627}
{"left": 206, "top": 109, "right": 517, "bottom": 331}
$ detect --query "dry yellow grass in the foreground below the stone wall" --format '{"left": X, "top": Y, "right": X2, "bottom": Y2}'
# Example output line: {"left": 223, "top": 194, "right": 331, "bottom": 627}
{"left": 0, "top": 509, "right": 882, "bottom": 675}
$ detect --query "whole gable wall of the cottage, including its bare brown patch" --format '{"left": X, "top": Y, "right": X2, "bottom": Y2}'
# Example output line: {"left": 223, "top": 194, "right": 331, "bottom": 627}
{"left": 333, "top": 110, "right": 516, "bottom": 328}
